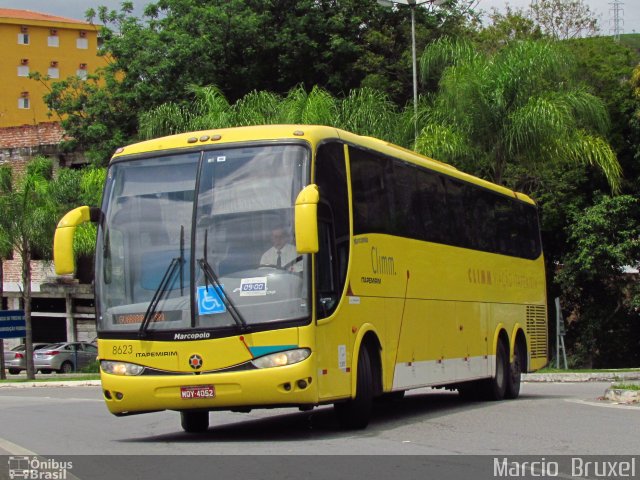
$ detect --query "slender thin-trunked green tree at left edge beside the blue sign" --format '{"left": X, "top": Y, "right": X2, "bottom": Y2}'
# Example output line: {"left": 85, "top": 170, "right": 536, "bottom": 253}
{"left": 0, "top": 157, "right": 57, "bottom": 379}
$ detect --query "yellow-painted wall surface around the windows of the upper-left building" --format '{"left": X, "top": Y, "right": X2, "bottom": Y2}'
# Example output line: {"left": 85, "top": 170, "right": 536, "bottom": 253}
{"left": 0, "top": 17, "right": 106, "bottom": 128}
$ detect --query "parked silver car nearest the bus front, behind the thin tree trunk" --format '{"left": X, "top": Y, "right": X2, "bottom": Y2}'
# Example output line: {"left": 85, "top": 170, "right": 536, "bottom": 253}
{"left": 33, "top": 342, "right": 98, "bottom": 373}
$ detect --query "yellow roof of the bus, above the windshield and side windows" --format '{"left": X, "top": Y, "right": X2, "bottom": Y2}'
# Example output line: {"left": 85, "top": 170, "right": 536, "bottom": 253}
{"left": 112, "top": 125, "right": 535, "bottom": 204}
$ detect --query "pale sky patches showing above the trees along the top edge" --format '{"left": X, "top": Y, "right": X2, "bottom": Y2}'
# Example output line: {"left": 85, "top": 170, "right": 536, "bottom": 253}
{"left": 0, "top": 0, "right": 640, "bottom": 35}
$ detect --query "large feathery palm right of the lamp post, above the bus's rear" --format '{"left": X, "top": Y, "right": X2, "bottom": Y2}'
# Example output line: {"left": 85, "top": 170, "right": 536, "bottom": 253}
{"left": 416, "top": 38, "right": 621, "bottom": 191}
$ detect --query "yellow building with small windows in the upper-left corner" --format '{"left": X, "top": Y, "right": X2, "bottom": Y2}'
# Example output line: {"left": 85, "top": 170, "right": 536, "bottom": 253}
{"left": 0, "top": 8, "right": 106, "bottom": 128}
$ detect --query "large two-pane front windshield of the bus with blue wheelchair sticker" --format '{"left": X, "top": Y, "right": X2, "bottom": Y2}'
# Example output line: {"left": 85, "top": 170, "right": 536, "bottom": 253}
{"left": 96, "top": 144, "right": 310, "bottom": 339}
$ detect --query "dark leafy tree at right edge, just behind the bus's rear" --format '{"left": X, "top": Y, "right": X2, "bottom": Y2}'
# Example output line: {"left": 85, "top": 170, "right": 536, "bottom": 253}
{"left": 558, "top": 195, "right": 640, "bottom": 367}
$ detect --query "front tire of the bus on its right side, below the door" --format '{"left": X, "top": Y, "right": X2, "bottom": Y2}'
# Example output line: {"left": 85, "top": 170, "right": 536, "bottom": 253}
{"left": 333, "top": 345, "right": 373, "bottom": 430}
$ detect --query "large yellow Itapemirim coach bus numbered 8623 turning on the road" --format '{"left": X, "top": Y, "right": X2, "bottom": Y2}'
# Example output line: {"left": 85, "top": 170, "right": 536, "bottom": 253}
{"left": 54, "top": 125, "right": 547, "bottom": 432}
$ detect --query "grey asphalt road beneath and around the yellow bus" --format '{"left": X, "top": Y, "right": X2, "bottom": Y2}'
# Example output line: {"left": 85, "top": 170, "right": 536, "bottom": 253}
{"left": 0, "top": 382, "right": 640, "bottom": 456}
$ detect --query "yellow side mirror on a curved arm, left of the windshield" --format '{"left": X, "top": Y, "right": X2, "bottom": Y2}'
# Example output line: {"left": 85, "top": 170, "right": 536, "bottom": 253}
{"left": 53, "top": 206, "right": 101, "bottom": 275}
